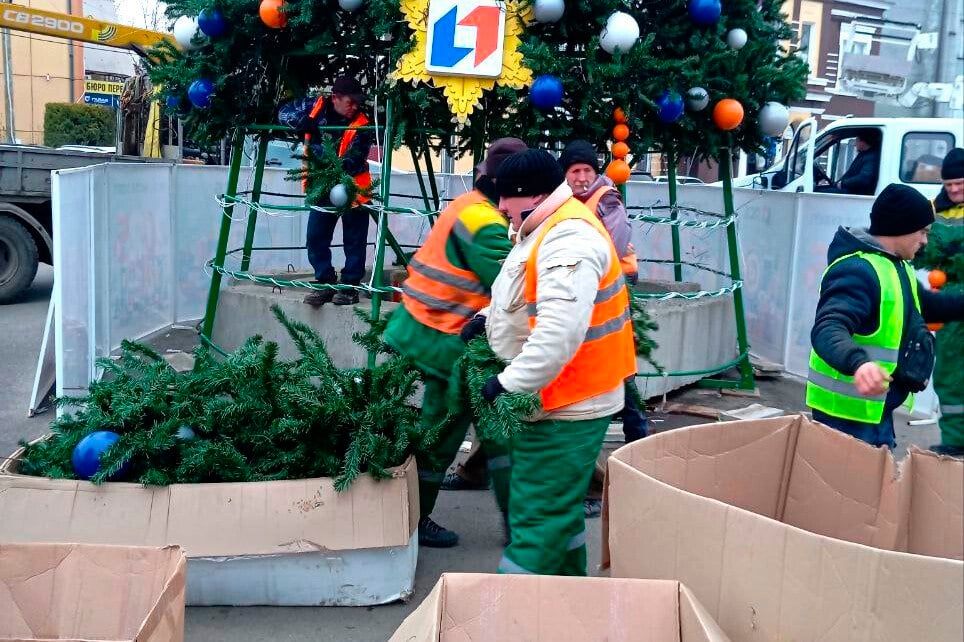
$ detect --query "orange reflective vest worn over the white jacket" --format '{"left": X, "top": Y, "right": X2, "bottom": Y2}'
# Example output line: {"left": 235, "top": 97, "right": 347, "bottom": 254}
{"left": 525, "top": 198, "right": 636, "bottom": 410}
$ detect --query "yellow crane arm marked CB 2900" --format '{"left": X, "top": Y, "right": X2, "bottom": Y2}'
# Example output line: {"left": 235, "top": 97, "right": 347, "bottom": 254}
{"left": 0, "top": 3, "right": 174, "bottom": 55}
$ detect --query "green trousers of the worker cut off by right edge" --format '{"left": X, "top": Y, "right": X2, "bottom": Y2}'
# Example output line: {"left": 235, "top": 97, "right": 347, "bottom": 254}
{"left": 934, "top": 321, "right": 964, "bottom": 448}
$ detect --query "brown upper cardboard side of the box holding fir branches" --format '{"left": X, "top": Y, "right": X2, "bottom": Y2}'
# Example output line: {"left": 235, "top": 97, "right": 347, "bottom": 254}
{"left": 0, "top": 459, "right": 418, "bottom": 557}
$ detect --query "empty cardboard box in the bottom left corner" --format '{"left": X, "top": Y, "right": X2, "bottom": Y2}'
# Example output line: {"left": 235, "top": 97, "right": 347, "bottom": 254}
{"left": 0, "top": 544, "right": 186, "bottom": 642}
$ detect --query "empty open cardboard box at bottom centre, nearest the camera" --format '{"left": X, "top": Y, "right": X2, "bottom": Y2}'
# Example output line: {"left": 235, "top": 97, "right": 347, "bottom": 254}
{"left": 389, "top": 573, "right": 728, "bottom": 642}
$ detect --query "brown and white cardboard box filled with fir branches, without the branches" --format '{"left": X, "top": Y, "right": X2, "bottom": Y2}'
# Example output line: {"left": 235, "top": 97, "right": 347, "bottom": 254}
{"left": 0, "top": 454, "right": 418, "bottom": 606}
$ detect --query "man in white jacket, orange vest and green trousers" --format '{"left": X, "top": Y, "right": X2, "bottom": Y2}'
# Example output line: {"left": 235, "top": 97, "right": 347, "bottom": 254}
{"left": 482, "top": 150, "right": 636, "bottom": 575}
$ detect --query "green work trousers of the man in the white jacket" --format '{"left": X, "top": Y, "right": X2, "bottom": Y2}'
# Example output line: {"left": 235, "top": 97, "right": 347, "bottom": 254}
{"left": 499, "top": 417, "right": 612, "bottom": 575}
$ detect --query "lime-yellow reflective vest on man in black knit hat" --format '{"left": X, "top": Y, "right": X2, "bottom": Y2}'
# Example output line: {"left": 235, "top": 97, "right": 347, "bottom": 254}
{"left": 807, "top": 252, "right": 920, "bottom": 424}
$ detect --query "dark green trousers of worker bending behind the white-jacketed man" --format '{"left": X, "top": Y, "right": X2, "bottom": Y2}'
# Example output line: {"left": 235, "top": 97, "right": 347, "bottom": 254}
{"left": 415, "top": 374, "right": 512, "bottom": 518}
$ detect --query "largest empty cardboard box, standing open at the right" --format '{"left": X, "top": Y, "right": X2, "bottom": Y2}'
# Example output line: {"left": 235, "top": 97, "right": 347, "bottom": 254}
{"left": 603, "top": 416, "right": 964, "bottom": 642}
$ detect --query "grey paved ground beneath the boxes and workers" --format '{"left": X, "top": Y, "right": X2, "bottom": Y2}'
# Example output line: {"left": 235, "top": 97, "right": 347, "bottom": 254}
{"left": 0, "top": 267, "right": 938, "bottom": 642}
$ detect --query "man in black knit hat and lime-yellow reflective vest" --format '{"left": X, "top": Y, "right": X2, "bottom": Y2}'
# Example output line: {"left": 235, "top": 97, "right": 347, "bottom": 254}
{"left": 807, "top": 184, "right": 964, "bottom": 448}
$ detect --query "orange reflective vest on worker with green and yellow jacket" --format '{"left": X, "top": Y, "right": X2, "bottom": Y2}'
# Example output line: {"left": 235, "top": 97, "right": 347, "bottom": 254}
{"left": 402, "top": 190, "right": 491, "bottom": 334}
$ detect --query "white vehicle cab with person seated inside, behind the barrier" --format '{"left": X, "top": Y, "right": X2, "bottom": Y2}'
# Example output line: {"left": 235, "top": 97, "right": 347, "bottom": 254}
{"left": 733, "top": 118, "right": 964, "bottom": 198}
